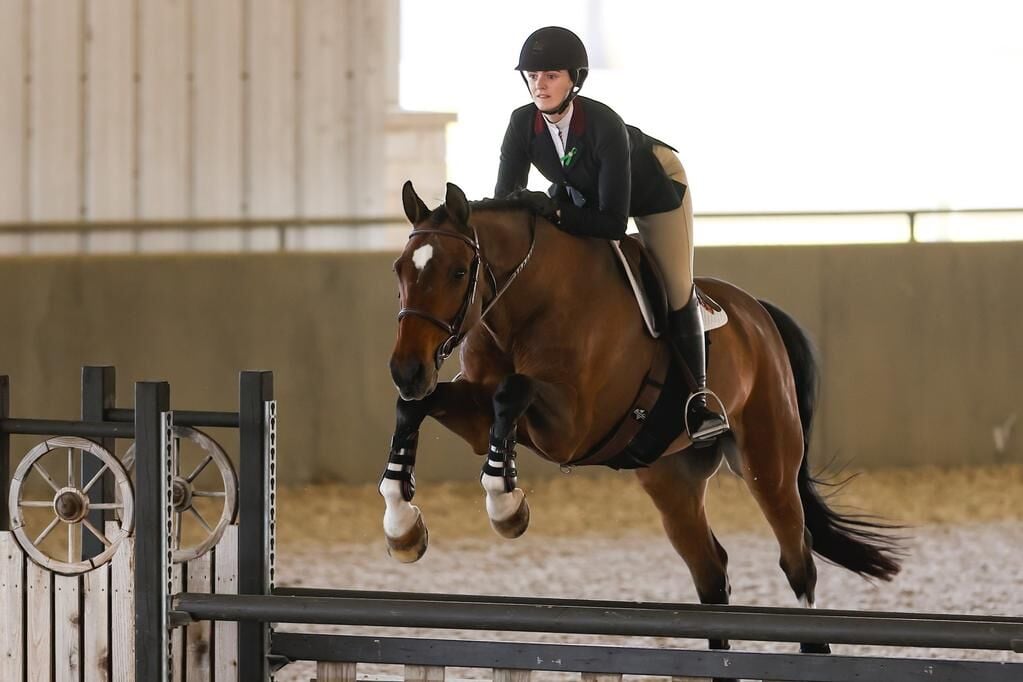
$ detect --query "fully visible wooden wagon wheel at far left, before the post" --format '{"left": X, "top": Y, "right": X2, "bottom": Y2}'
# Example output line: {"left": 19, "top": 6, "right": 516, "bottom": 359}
{"left": 8, "top": 437, "right": 135, "bottom": 576}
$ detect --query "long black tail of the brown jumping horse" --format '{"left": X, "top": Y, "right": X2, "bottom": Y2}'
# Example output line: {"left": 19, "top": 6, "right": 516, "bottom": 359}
{"left": 760, "top": 301, "right": 901, "bottom": 580}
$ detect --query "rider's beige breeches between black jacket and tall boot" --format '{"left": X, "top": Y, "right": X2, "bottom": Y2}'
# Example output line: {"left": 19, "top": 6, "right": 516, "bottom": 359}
{"left": 635, "top": 144, "right": 693, "bottom": 310}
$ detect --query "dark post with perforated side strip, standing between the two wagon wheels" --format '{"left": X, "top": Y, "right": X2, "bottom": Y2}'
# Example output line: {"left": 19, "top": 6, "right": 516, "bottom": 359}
{"left": 135, "top": 381, "right": 174, "bottom": 682}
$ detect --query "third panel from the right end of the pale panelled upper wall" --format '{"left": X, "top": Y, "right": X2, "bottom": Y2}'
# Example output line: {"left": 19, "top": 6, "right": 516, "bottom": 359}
{"left": 246, "top": 0, "right": 297, "bottom": 224}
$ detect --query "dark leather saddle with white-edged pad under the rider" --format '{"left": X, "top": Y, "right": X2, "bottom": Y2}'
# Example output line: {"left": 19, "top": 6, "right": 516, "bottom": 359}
{"left": 609, "top": 234, "right": 728, "bottom": 338}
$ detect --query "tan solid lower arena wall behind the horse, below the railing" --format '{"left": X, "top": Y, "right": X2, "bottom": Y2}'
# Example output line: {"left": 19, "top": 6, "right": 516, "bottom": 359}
{"left": 0, "top": 243, "right": 1023, "bottom": 482}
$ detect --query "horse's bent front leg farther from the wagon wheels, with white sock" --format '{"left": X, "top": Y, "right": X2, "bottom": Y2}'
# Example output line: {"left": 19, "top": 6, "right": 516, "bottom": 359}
{"left": 480, "top": 374, "right": 574, "bottom": 538}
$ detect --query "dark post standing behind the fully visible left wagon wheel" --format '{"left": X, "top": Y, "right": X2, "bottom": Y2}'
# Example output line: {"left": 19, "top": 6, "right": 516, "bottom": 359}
{"left": 82, "top": 366, "right": 117, "bottom": 559}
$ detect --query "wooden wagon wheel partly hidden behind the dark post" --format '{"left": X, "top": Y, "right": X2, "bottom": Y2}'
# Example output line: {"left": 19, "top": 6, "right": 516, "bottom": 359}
{"left": 123, "top": 426, "right": 238, "bottom": 563}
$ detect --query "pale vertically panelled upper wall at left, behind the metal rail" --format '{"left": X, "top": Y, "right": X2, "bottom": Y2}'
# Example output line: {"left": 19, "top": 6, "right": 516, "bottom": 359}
{"left": 0, "top": 0, "right": 453, "bottom": 254}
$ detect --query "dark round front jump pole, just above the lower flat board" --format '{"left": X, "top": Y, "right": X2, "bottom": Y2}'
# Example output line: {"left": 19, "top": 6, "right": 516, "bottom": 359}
{"left": 174, "top": 593, "right": 1023, "bottom": 651}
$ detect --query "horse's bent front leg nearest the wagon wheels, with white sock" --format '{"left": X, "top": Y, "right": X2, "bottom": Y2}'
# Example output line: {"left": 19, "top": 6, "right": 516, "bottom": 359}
{"left": 380, "top": 380, "right": 492, "bottom": 563}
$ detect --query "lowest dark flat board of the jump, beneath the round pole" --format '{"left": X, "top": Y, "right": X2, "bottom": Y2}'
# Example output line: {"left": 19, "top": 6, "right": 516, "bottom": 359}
{"left": 271, "top": 630, "right": 1023, "bottom": 682}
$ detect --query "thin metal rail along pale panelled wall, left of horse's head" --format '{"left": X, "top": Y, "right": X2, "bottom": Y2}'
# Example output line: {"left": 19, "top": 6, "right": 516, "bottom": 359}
{"left": 0, "top": 216, "right": 408, "bottom": 232}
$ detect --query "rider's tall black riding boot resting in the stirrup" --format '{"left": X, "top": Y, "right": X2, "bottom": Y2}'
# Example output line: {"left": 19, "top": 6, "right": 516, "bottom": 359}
{"left": 668, "top": 289, "right": 728, "bottom": 448}
